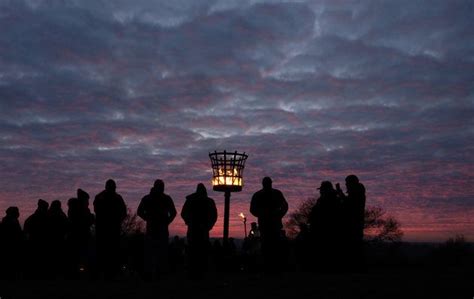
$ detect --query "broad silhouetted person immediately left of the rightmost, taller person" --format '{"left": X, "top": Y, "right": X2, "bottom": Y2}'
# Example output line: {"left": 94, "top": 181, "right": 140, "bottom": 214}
{"left": 308, "top": 181, "right": 342, "bottom": 270}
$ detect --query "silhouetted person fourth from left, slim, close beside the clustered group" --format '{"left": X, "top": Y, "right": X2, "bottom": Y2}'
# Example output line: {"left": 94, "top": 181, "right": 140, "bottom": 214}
{"left": 67, "top": 189, "right": 94, "bottom": 276}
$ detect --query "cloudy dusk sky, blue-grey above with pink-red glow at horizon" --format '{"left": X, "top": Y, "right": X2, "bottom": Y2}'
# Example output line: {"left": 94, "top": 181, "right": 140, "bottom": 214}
{"left": 0, "top": 0, "right": 474, "bottom": 241}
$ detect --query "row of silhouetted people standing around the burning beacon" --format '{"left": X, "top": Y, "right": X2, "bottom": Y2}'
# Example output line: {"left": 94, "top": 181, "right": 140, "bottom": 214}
{"left": 0, "top": 175, "right": 365, "bottom": 280}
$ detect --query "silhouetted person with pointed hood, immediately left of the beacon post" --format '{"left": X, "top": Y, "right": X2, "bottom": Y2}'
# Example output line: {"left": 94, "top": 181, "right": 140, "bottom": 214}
{"left": 181, "top": 183, "right": 217, "bottom": 276}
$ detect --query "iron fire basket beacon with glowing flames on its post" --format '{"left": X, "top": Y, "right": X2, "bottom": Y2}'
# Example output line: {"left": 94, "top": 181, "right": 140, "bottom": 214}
{"left": 209, "top": 151, "right": 248, "bottom": 244}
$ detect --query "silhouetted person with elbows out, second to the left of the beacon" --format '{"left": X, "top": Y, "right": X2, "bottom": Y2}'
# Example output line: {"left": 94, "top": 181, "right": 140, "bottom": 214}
{"left": 137, "top": 180, "right": 176, "bottom": 278}
